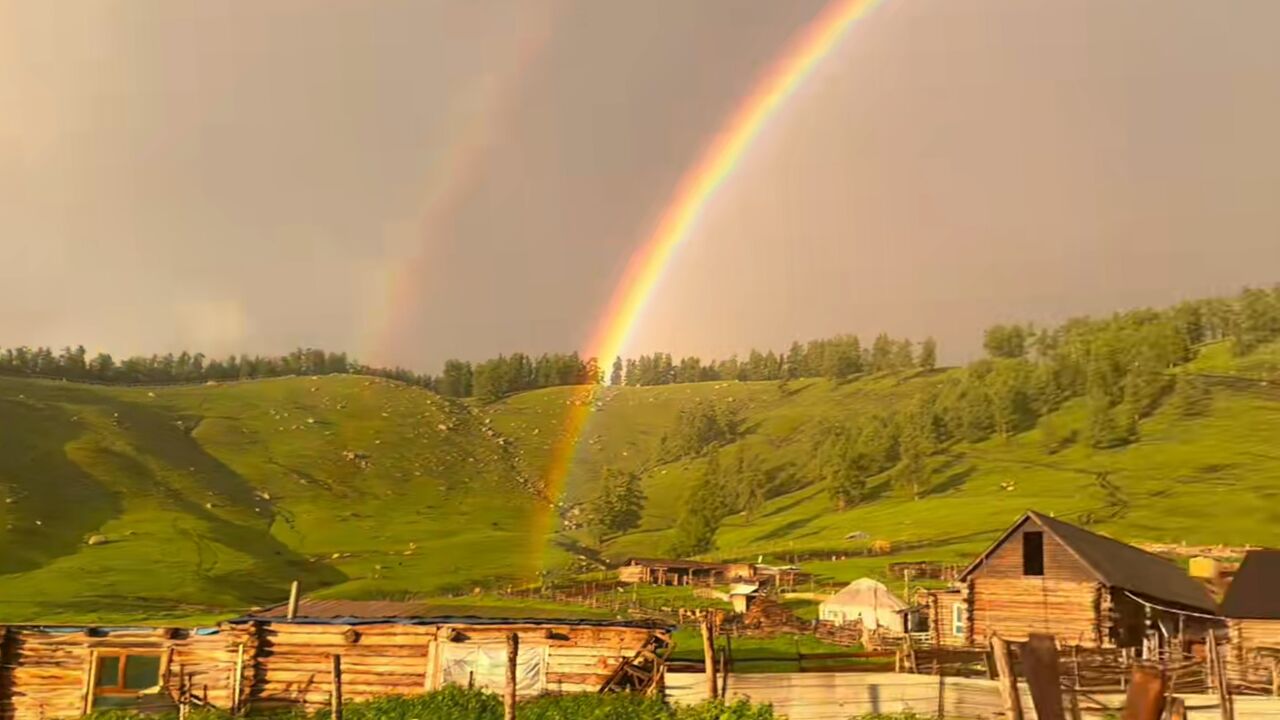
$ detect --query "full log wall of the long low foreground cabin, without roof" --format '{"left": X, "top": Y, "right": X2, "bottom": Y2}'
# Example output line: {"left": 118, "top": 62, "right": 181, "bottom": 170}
{"left": 0, "top": 623, "right": 655, "bottom": 720}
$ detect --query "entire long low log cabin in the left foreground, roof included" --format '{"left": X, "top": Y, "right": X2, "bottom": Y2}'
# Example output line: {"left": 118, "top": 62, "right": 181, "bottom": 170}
{"left": 0, "top": 600, "right": 671, "bottom": 720}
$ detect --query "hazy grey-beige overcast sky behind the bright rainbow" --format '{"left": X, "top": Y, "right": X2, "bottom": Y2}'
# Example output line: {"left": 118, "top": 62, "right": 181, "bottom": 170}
{"left": 0, "top": 0, "right": 1280, "bottom": 370}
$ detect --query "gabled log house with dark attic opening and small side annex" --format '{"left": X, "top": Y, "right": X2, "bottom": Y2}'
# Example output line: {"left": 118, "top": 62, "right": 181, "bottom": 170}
{"left": 933, "top": 511, "right": 1221, "bottom": 655}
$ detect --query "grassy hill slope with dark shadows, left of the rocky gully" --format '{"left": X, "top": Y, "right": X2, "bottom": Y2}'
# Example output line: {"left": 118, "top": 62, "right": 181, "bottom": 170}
{"left": 0, "top": 375, "right": 558, "bottom": 619}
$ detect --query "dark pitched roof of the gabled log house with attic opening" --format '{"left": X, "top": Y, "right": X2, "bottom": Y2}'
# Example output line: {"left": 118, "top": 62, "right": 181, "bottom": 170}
{"left": 960, "top": 510, "right": 1217, "bottom": 614}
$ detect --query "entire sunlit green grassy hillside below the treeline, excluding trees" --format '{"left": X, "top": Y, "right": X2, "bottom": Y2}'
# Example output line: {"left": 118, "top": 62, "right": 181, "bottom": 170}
{"left": 0, "top": 345, "right": 1280, "bottom": 621}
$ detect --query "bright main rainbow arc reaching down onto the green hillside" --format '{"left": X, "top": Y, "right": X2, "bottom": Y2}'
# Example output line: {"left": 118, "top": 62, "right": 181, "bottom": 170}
{"left": 534, "top": 0, "right": 882, "bottom": 569}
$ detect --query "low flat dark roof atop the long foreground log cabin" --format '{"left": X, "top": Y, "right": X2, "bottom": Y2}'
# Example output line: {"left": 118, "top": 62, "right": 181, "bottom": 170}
{"left": 232, "top": 600, "right": 667, "bottom": 629}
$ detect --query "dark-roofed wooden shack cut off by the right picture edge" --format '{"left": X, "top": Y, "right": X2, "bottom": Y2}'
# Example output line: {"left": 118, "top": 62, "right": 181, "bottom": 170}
{"left": 1222, "top": 550, "right": 1280, "bottom": 691}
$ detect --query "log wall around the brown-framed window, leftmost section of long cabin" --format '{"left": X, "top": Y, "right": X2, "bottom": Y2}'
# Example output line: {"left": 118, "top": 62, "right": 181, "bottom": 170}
{"left": 0, "top": 626, "right": 253, "bottom": 720}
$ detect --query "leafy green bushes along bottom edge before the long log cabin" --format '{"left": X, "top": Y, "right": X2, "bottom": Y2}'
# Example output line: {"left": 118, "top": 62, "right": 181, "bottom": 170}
{"left": 90, "top": 687, "right": 782, "bottom": 720}
